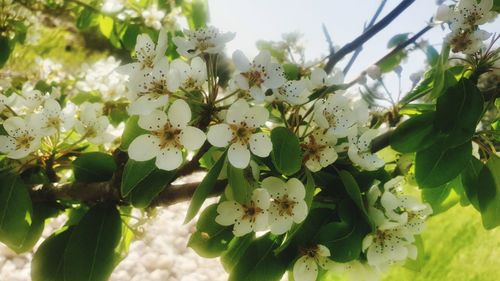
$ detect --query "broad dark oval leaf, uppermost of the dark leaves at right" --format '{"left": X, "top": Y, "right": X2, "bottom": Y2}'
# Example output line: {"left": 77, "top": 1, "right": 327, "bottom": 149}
{"left": 434, "top": 79, "right": 484, "bottom": 146}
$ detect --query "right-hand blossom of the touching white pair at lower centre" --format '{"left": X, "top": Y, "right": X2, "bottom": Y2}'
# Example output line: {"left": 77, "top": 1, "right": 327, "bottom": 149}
{"left": 261, "top": 177, "right": 308, "bottom": 234}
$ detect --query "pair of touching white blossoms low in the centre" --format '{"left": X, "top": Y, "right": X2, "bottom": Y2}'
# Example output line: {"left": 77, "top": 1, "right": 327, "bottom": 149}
{"left": 215, "top": 177, "right": 308, "bottom": 236}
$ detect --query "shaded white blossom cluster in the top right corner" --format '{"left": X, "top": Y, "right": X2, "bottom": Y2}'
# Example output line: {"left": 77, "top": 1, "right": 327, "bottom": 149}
{"left": 435, "top": 0, "right": 496, "bottom": 54}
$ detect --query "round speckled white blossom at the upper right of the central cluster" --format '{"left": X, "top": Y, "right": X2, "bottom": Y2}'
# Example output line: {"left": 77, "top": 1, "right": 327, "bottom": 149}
{"left": 314, "top": 94, "right": 357, "bottom": 138}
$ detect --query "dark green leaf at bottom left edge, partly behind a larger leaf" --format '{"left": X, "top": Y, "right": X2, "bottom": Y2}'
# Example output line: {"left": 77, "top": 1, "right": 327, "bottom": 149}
{"left": 31, "top": 226, "right": 75, "bottom": 281}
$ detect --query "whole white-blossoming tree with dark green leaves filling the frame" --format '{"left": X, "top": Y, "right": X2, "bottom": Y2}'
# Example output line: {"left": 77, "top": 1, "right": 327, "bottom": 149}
{"left": 0, "top": 0, "right": 500, "bottom": 281}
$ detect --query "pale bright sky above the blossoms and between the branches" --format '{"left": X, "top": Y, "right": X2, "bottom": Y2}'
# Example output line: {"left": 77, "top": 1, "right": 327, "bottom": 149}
{"left": 208, "top": 0, "right": 500, "bottom": 94}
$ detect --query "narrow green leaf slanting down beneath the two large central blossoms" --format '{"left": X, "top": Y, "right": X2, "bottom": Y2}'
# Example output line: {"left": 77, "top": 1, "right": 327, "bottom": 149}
{"left": 184, "top": 152, "right": 226, "bottom": 223}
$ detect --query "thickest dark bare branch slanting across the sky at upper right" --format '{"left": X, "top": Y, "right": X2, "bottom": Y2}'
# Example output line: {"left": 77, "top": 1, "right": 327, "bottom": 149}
{"left": 325, "top": 0, "right": 415, "bottom": 73}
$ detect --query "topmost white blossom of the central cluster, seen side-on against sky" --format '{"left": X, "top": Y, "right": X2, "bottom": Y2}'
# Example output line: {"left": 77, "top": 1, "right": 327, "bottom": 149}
{"left": 172, "top": 26, "right": 235, "bottom": 58}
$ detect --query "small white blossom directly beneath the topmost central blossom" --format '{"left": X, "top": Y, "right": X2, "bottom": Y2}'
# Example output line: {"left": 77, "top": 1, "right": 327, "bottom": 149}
{"left": 170, "top": 57, "right": 207, "bottom": 91}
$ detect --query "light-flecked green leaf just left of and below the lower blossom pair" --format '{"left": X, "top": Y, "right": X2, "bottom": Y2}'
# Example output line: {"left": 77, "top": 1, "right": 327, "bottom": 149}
{"left": 188, "top": 204, "right": 234, "bottom": 258}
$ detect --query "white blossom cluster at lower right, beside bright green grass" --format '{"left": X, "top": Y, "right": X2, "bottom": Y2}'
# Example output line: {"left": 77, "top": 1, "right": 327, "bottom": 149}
{"left": 363, "top": 176, "right": 432, "bottom": 270}
